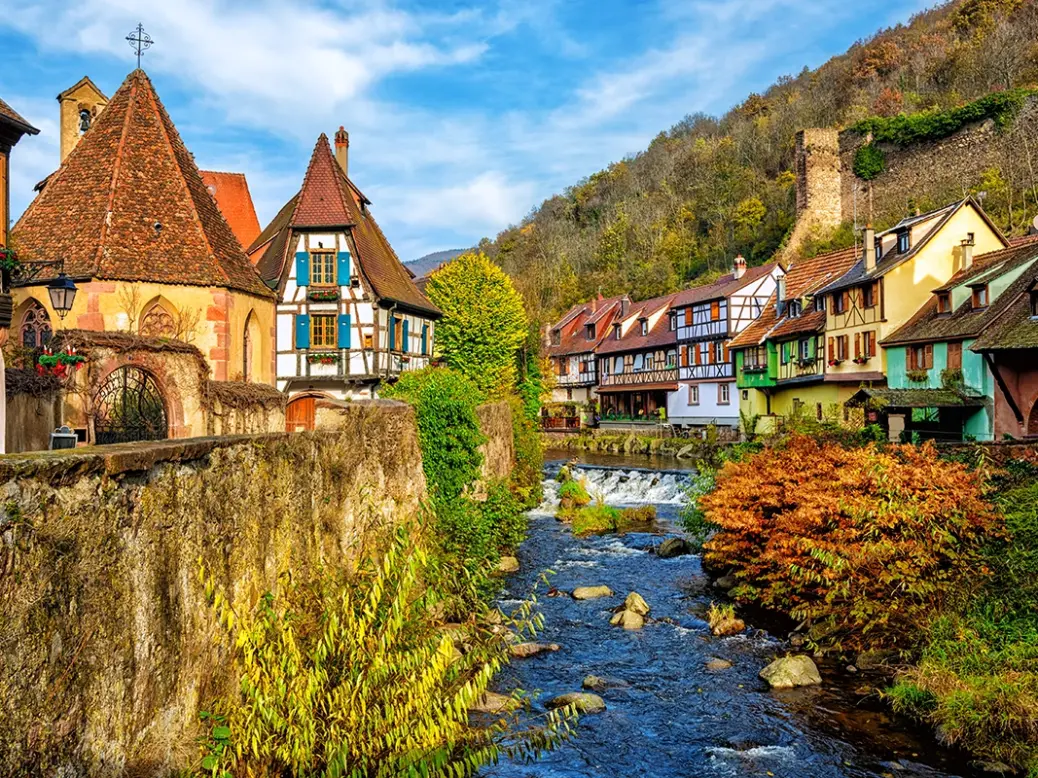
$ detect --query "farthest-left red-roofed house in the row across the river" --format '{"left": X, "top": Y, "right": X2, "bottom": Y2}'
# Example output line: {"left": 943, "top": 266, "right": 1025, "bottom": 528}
{"left": 545, "top": 295, "right": 631, "bottom": 405}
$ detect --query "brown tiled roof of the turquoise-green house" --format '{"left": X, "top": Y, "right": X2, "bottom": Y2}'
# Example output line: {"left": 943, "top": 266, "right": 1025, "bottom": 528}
{"left": 882, "top": 239, "right": 1038, "bottom": 345}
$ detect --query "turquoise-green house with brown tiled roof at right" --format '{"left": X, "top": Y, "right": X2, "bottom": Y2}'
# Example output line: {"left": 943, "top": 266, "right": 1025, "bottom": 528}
{"left": 851, "top": 238, "right": 1038, "bottom": 441}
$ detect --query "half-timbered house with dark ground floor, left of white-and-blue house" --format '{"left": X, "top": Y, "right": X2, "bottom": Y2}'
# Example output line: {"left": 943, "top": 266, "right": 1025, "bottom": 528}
{"left": 596, "top": 295, "right": 678, "bottom": 427}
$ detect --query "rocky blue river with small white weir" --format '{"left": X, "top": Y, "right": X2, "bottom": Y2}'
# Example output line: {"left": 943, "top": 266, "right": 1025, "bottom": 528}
{"left": 484, "top": 457, "right": 974, "bottom": 778}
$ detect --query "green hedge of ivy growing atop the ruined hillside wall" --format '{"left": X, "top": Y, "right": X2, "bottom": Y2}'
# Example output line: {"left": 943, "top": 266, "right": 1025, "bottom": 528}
{"left": 850, "top": 87, "right": 1038, "bottom": 149}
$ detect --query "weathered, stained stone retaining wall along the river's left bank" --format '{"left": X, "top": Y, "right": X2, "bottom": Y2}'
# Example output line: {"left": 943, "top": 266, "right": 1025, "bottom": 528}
{"left": 0, "top": 401, "right": 512, "bottom": 778}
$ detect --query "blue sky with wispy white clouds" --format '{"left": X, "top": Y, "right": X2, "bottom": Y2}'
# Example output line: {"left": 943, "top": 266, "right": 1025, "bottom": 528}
{"left": 0, "top": 0, "right": 927, "bottom": 260}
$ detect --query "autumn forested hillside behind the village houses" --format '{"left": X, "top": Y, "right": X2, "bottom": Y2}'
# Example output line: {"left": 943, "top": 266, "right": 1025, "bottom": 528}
{"left": 482, "top": 0, "right": 1038, "bottom": 322}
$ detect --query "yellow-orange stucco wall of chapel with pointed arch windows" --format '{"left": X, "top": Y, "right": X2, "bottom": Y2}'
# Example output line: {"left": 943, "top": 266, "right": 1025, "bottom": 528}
{"left": 12, "top": 281, "right": 274, "bottom": 385}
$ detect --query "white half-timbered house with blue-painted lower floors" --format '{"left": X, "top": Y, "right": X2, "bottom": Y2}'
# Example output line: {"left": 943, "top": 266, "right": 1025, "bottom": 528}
{"left": 666, "top": 256, "right": 784, "bottom": 427}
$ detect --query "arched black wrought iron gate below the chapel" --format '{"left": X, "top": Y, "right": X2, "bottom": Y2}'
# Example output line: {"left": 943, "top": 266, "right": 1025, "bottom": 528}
{"left": 93, "top": 365, "right": 169, "bottom": 444}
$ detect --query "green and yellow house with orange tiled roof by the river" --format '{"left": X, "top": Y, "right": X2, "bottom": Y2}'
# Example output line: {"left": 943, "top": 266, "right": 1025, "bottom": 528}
{"left": 729, "top": 248, "right": 858, "bottom": 432}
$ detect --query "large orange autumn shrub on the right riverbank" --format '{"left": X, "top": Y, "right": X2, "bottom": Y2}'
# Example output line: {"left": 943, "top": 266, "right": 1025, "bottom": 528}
{"left": 700, "top": 437, "right": 999, "bottom": 650}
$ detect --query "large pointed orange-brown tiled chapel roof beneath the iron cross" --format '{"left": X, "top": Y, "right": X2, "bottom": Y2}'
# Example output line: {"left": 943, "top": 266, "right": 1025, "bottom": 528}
{"left": 13, "top": 70, "right": 270, "bottom": 297}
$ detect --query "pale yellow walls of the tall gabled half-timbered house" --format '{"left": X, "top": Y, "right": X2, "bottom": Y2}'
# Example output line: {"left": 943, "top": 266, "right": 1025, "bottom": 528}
{"left": 825, "top": 205, "right": 1003, "bottom": 374}
